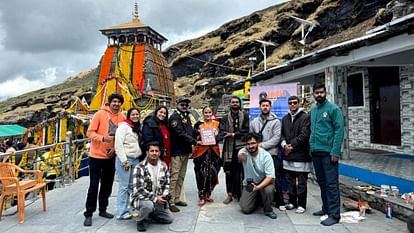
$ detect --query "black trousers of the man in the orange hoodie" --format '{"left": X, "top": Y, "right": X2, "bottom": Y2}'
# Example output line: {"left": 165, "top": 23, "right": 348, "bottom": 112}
{"left": 83, "top": 157, "right": 115, "bottom": 217}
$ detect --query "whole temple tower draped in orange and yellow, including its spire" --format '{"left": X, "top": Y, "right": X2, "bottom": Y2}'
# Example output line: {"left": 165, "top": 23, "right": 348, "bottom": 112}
{"left": 90, "top": 3, "right": 175, "bottom": 110}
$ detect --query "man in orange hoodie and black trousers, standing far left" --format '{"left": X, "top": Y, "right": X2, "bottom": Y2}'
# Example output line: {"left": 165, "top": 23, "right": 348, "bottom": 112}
{"left": 83, "top": 93, "right": 125, "bottom": 227}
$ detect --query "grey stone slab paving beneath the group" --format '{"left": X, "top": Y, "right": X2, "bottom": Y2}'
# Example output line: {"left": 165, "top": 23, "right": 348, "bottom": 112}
{"left": 0, "top": 161, "right": 408, "bottom": 233}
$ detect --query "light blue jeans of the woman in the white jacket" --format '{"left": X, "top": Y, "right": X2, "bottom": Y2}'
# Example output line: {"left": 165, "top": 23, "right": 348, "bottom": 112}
{"left": 115, "top": 158, "right": 138, "bottom": 219}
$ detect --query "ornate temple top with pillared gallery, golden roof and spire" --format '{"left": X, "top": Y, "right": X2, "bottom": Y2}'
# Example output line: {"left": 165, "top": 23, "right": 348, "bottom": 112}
{"left": 99, "top": 3, "right": 167, "bottom": 50}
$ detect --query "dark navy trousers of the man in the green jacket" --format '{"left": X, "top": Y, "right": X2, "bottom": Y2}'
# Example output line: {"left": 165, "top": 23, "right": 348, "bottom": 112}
{"left": 312, "top": 152, "right": 341, "bottom": 219}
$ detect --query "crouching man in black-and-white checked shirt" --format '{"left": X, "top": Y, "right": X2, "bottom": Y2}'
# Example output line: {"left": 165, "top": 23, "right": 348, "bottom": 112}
{"left": 131, "top": 142, "right": 173, "bottom": 231}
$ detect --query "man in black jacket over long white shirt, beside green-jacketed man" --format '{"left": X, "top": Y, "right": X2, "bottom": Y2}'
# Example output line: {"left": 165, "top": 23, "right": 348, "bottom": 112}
{"left": 281, "top": 96, "right": 312, "bottom": 214}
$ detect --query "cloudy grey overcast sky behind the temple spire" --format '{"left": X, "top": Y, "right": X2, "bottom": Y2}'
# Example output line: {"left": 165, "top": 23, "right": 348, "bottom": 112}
{"left": 0, "top": 0, "right": 283, "bottom": 100}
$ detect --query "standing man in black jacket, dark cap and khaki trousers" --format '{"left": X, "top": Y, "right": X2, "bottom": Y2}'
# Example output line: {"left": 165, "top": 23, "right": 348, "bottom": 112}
{"left": 169, "top": 97, "right": 197, "bottom": 212}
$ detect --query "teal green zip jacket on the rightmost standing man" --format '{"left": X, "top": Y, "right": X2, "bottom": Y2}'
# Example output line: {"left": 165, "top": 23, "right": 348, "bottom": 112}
{"left": 309, "top": 100, "right": 344, "bottom": 157}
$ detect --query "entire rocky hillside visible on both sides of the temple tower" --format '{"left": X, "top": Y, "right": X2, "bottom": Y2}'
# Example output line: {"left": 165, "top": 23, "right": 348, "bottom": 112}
{"left": 0, "top": 0, "right": 414, "bottom": 126}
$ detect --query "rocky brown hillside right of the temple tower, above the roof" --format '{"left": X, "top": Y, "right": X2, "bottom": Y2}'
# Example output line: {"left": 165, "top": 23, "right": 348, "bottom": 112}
{"left": 164, "top": 0, "right": 414, "bottom": 106}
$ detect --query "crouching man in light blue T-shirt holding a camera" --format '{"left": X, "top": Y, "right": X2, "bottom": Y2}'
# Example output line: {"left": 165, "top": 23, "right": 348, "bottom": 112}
{"left": 238, "top": 133, "right": 277, "bottom": 219}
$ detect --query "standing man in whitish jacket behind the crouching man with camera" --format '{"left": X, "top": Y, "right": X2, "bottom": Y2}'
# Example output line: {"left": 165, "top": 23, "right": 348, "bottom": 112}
{"left": 250, "top": 98, "right": 286, "bottom": 211}
